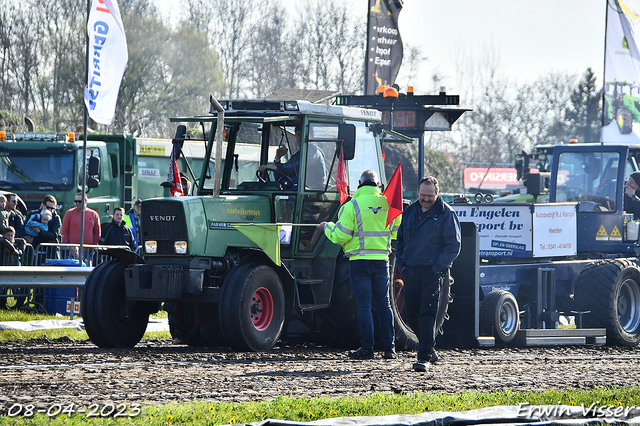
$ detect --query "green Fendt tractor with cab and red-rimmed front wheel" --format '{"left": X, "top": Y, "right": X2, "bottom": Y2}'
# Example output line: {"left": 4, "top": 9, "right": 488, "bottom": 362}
{"left": 82, "top": 95, "right": 432, "bottom": 351}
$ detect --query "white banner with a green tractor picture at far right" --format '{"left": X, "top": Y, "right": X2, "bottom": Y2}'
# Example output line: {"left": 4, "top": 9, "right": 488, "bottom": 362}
{"left": 600, "top": 0, "right": 640, "bottom": 144}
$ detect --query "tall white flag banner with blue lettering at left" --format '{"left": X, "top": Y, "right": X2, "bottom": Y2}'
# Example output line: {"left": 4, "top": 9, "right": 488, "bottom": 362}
{"left": 84, "top": 0, "right": 129, "bottom": 125}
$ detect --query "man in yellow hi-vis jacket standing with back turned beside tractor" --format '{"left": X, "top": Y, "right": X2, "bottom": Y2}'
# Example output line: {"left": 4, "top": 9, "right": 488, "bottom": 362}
{"left": 318, "top": 170, "right": 401, "bottom": 359}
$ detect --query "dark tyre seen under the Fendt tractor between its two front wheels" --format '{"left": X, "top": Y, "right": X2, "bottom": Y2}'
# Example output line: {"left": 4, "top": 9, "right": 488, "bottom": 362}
{"left": 164, "top": 302, "right": 224, "bottom": 346}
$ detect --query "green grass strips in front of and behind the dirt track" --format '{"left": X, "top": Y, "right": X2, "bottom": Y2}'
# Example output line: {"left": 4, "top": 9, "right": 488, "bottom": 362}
{"left": 0, "top": 311, "right": 640, "bottom": 426}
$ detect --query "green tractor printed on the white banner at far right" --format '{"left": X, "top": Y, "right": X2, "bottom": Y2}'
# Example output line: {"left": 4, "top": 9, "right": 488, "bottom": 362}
{"left": 604, "top": 81, "right": 640, "bottom": 135}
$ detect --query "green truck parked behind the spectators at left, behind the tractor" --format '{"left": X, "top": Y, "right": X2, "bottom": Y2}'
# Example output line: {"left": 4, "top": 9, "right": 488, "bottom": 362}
{"left": 0, "top": 132, "right": 211, "bottom": 223}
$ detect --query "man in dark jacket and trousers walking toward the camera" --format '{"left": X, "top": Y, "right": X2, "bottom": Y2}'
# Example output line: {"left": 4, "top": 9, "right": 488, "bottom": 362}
{"left": 396, "top": 176, "right": 460, "bottom": 371}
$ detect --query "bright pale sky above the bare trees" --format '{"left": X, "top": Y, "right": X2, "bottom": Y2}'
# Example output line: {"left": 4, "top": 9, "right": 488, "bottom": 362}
{"left": 154, "top": 0, "right": 604, "bottom": 93}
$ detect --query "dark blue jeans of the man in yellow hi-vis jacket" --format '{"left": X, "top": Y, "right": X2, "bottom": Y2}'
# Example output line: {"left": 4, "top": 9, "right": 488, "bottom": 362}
{"left": 349, "top": 260, "right": 395, "bottom": 351}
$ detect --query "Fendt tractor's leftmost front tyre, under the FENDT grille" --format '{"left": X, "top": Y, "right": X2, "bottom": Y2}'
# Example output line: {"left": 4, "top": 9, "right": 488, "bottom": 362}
{"left": 82, "top": 260, "right": 151, "bottom": 348}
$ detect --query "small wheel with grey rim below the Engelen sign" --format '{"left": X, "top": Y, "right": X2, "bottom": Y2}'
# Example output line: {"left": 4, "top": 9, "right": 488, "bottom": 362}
{"left": 480, "top": 290, "right": 520, "bottom": 343}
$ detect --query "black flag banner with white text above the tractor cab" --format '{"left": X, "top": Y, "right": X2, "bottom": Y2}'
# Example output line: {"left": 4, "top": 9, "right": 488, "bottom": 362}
{"left": 364, "top": 0, "right": 403, "bottom": 95}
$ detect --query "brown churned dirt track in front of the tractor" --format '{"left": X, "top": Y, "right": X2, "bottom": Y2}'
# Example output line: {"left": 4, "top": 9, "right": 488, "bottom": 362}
{"left": 0, "top": 338, "right": 640, "bottom": 413}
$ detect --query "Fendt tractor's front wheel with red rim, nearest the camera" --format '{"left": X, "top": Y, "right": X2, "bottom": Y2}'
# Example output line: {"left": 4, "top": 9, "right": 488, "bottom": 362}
{"left": 219, "top": 264, "right": 285, "bottom": 352}
